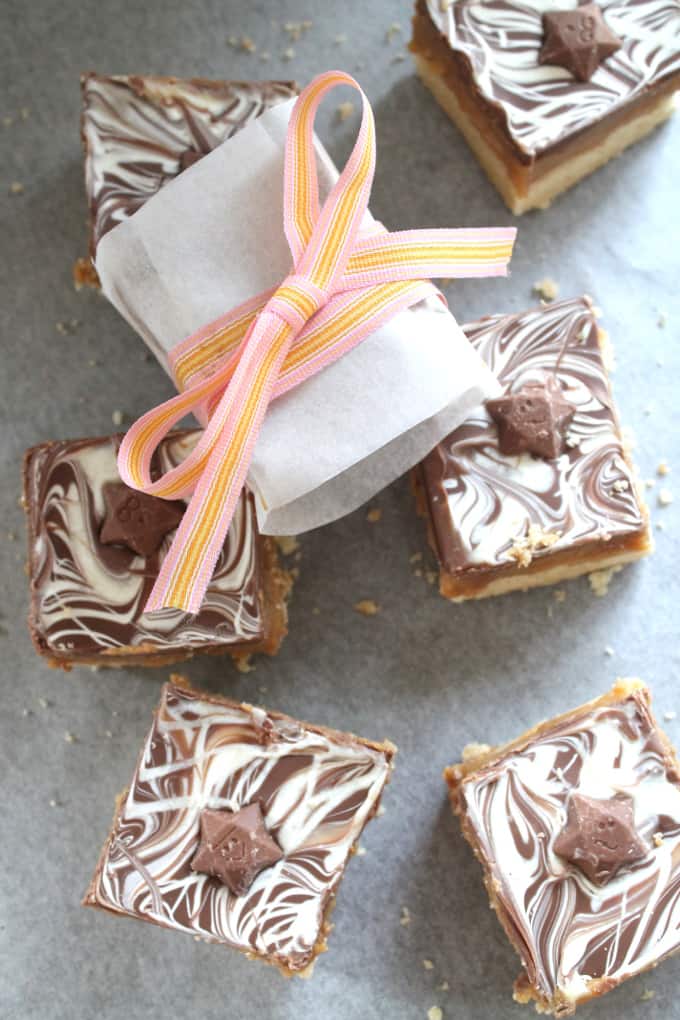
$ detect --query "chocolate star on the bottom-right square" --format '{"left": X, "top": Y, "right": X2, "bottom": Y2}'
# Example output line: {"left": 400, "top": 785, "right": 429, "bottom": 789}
{"left": 555, "top": 794, "right": 647, "bottom": 885}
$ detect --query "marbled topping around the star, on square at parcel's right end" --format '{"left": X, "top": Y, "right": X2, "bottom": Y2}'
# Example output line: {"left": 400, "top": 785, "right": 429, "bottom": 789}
{"left": 423, "top": 299, "right": 643, "bottom": 571}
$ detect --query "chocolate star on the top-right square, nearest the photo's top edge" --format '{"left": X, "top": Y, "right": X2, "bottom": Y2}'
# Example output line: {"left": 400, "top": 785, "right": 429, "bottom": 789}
{"left": 538, "top": 3, "right": 621, "bottom": 82}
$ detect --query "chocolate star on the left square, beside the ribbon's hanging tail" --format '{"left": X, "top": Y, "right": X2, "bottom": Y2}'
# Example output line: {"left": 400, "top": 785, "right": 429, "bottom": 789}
{"left": 99, "top": 481, "right": 187, "bottom": 556}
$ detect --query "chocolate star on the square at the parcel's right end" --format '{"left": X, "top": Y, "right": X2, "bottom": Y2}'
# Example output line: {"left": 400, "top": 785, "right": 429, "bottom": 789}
{"left": 486, "top": 375, "right": 576, "bottom": 459}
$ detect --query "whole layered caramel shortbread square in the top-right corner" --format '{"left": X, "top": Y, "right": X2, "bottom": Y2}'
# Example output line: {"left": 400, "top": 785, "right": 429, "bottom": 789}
{"left": 411, "top": 0, "right": 680, "bottom": 213}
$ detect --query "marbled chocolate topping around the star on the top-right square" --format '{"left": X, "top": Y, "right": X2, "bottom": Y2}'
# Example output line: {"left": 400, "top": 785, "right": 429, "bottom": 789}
{"left": 427, "top": 0, "right": 680, "bottom": 156}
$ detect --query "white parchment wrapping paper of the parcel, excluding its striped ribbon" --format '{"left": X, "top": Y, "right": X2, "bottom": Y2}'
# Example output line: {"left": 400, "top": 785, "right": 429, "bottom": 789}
{"left": 97, "top": 100, "right": 499, "bottom": 534}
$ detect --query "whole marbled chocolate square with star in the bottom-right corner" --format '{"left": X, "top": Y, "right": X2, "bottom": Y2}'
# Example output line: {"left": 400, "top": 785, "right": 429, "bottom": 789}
{"left": 444, "top": 680, "right": 680, "bottom": 1017}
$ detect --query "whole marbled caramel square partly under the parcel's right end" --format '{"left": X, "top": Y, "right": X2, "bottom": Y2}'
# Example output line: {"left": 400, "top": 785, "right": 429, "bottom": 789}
{"left": 415, "top": 298, "right": 651, "bottom": 602}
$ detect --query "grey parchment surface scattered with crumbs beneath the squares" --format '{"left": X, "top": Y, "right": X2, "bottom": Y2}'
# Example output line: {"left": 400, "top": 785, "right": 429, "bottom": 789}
{"left": 0, "top": 0, "right": 680, "bottom": 1020}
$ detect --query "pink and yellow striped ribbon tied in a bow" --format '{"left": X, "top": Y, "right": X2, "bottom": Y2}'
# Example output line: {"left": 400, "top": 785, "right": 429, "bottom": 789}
{"left": 118, "top": 71, "right": 516, "bottom": 613}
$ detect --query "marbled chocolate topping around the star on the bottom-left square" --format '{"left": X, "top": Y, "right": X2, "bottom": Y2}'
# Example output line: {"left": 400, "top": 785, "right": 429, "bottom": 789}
{"left": 87, "top": 684, "right": 390, "bottom": 970}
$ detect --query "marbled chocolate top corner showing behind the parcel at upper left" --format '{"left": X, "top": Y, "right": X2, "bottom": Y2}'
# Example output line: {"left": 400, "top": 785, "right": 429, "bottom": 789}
{"left": 83, "top": 74, "right": 296, "bottom": 248}
